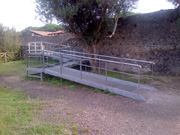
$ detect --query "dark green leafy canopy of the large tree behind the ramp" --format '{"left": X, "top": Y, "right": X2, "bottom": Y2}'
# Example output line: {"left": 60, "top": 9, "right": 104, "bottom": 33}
{"left": 36, "top": 0, "right": 138, "bottom": 71}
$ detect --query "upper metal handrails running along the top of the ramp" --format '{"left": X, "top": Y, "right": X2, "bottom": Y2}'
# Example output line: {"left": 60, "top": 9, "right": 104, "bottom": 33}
{"left": 28, "top": 41, "right": 155, "bottom": 85}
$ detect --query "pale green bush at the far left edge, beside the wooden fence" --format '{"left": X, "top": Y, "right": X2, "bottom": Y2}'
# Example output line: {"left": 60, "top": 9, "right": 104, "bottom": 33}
{"left": 0, "top": 24, "right": 21, "bottom": 61}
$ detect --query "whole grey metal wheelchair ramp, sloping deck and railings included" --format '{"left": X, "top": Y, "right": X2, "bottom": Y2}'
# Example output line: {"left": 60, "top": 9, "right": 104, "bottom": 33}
{"left": 26, "top": 43, "right": 156, "bottom": 102}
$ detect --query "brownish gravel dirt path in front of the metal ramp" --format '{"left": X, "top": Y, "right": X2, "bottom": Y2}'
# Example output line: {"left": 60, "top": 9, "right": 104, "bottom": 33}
{"left": 0, "top": 77, "right": 180, "bottom": 135}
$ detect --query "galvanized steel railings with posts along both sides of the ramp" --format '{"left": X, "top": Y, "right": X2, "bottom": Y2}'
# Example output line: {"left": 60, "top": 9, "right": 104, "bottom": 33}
{"left": 27, "top": 42, "right": 155, "bottom": 86}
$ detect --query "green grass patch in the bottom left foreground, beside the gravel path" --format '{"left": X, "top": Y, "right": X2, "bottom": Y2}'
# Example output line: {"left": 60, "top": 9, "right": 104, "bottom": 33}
{"left": 0, "top": 84, "right": 67, "bottom": 135}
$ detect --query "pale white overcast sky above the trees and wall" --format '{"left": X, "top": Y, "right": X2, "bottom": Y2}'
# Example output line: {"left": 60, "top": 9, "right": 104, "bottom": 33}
{"left": 0, "top": 0, "right": 174, "bottom": 31}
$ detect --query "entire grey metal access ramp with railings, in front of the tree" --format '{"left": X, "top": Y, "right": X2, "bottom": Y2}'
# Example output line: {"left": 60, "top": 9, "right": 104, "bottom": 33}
{"left": 26, "top": 42, "right": 156, "bottom": 102}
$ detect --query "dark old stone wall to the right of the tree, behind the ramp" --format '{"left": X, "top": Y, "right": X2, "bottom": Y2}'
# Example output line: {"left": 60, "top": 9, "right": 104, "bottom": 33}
{"left": 101, "top": 10, "right": 180, "bottom": 74}
